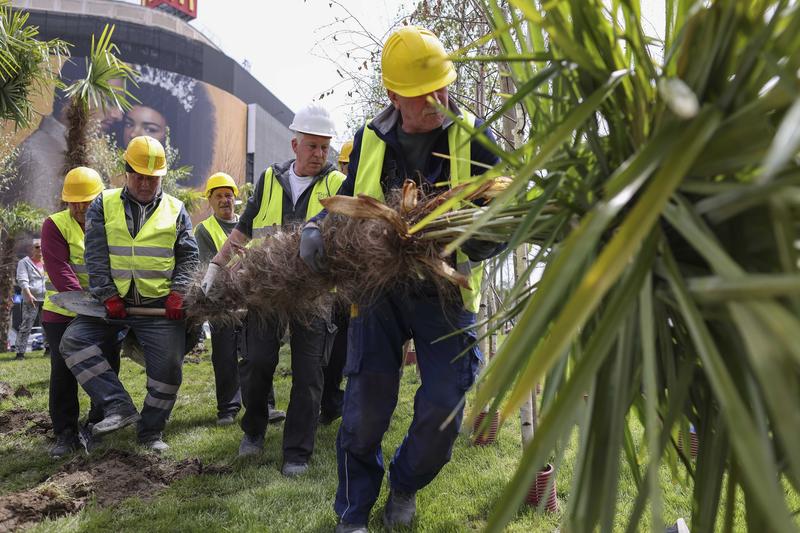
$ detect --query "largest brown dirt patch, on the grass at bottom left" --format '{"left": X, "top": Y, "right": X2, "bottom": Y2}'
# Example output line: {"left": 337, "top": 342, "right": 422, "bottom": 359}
{"left": 0, "top": 450, "right": 206, "bottom": 533}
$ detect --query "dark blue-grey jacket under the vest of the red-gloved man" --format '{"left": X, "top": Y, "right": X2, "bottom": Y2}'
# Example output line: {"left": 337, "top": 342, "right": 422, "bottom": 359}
{"left": 83, "top": 188, "right": 200, "bottom": 305}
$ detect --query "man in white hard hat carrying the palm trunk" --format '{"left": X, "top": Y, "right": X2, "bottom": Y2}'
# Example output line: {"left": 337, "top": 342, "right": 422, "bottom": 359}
{"left": 202, "top": 104, "right": 345, "bottom": 477}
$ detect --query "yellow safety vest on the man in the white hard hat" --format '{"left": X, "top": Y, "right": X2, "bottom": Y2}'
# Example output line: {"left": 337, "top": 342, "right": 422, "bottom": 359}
{"left": 253, "top": 167, "right": 347, "bottom": 239}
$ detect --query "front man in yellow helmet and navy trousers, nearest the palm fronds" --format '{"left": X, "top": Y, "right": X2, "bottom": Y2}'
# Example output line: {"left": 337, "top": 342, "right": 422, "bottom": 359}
{"left": 300, "top": 26, "right": 501, "bottom": 533}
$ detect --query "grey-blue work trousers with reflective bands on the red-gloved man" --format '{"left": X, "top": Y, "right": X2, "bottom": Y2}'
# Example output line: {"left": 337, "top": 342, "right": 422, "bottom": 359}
{"left": 61, "top": 316, "right": 186, "bottom": 442}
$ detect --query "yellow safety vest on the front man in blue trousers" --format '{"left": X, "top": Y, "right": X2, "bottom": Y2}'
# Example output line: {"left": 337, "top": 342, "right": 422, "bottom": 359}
{"left": 354, "top": 111, "right": 483, "bottom": 313}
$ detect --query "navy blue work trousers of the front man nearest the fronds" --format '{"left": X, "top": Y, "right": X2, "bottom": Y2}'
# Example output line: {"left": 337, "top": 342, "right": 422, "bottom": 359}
{"left": 334, "top": 293, "right": 481, "bottom": 523}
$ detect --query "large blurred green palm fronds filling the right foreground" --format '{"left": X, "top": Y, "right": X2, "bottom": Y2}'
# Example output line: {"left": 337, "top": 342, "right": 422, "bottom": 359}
{"left": 422, "top": 0, "right": 800, "bottom": 532}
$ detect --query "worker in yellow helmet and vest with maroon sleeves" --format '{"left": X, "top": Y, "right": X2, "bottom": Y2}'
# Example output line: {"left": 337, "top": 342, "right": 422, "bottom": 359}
{"left": 42, "top": 167, "right": 119, "bottom": 458}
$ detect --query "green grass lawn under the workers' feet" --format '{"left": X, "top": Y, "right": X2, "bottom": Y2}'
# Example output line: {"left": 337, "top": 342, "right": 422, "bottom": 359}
{"left": 0, "top": 352, "right": 760, "bottom": 532}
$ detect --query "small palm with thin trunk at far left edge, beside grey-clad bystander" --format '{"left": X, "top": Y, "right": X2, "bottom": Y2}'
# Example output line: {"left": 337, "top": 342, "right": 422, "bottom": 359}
{"left": 0, "top": 203, "right": 45, "bottom": 351}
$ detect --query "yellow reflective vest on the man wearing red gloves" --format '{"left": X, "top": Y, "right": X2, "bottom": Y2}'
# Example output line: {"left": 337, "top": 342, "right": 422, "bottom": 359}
{"left": 103, "top": 189, "right": 183, "bottom": 298}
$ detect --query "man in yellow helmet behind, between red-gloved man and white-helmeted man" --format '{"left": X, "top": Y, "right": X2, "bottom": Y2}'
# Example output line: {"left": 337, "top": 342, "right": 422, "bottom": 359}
{"left": 194, "top": 172, "right": 286, "bottom": 426}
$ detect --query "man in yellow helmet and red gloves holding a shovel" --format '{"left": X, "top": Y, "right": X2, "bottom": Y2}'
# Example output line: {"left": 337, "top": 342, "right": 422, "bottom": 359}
{"left": 61, "top": 136, "right": 198, "bottom": 452}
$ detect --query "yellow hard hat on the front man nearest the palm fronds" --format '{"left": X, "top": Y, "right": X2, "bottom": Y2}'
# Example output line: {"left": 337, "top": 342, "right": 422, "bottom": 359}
{"left": 381, "top": 26, "right": 456, "bottom": 98}
